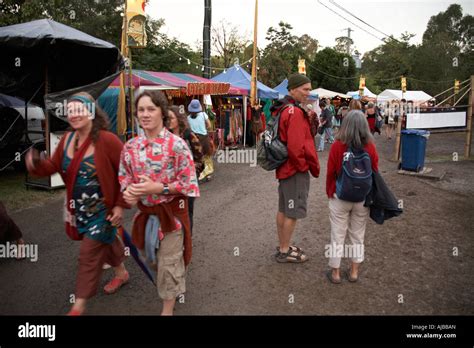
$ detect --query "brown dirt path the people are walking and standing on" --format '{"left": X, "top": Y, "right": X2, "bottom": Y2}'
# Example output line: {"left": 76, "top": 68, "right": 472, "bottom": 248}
{"left": 0, "top": 135, "right": 474, "bottom": 315}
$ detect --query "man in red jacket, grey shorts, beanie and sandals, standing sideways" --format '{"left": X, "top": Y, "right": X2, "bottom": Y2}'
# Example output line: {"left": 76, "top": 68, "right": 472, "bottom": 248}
{"left": 272, "top": 74, "right": 319, "bottom": 262}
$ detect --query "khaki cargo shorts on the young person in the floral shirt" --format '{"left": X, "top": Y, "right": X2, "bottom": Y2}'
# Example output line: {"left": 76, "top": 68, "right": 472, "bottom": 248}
{"left": 156, "top": 229, "right": 186, "bottom": 300}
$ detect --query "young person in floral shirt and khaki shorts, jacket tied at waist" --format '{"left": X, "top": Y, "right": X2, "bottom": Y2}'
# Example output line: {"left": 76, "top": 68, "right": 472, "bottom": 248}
{"left": 119, "top": 91, "right": 199, "bottom": 315}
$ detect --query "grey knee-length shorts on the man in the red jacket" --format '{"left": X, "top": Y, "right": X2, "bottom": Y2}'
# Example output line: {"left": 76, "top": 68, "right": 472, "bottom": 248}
{"left": 278, "top": 172, "right": 309, "bottom": 219}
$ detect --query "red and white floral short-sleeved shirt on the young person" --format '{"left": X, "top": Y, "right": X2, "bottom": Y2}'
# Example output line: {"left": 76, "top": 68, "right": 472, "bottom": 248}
{"left": 118, "top": 128, "right": 199, "bottom": 206}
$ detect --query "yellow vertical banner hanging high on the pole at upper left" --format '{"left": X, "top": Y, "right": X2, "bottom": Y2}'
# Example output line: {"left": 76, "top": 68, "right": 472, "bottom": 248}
{"left": 126, "top": 0, "right": 146, "bottom": 48}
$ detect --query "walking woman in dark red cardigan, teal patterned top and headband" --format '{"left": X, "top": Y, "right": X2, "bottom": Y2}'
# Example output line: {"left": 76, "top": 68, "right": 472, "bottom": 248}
{"left": 26, "top": 92, "right": 130, "bottom": 315}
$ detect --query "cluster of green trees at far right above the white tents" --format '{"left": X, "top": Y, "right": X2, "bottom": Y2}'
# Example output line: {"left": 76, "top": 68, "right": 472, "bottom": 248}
{"left": 361, "top": 4, "right": 474, "bottom": 101}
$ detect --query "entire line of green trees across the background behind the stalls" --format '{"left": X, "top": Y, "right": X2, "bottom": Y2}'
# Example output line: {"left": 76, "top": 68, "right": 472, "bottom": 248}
{"left": 0, "top": 0, "right": 474, "bottom": 95}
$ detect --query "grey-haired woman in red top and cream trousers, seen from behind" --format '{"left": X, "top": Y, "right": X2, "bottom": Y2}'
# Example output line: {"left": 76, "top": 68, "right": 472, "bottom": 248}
{"left": 326, "top": 110, "right": 379, "bottom": 284}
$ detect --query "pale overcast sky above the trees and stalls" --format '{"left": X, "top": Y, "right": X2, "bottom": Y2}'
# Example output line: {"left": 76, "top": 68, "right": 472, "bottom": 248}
{"left": 147, "top": 0, "right": 474, "bottom": 54}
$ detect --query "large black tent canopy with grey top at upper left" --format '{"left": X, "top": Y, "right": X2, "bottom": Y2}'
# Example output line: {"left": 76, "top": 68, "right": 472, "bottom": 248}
{"left": 0, "top": 19, "right": 123, "bottom": 106}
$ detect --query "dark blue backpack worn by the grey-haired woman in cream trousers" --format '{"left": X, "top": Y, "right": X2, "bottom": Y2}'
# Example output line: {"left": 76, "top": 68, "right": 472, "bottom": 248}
{"left": 336, "top": 148, "right": 372, "bottom": 202}
